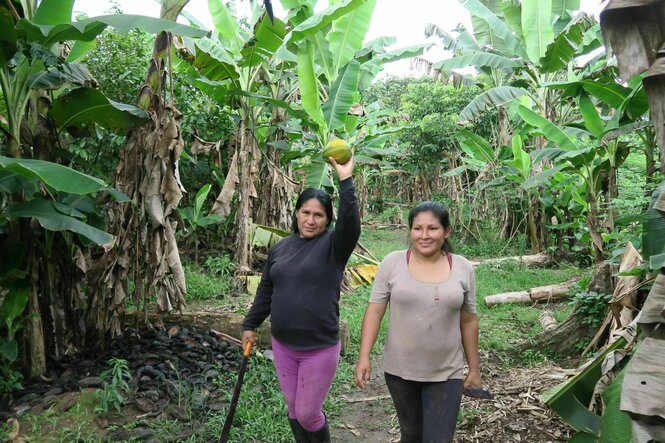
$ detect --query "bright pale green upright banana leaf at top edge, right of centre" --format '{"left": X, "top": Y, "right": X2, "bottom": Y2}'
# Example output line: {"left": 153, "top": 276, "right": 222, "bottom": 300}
{"left": 522, "top": 0, "right": 554, "bottom": 64}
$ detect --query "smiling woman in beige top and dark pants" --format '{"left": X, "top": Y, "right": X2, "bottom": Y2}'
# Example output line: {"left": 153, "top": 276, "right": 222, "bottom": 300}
{"left": 355, "top": 202, "right": 481, "bottom": 443}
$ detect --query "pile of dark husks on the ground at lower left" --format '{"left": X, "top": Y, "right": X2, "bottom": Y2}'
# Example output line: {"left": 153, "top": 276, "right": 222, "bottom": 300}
{"left": 0, "top": 326, "right": 242, "bottom": 441}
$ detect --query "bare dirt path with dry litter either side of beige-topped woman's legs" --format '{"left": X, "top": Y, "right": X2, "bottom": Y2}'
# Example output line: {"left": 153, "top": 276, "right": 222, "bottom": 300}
{"left": 331, "top": 360, "right": 571, "bottom": 443}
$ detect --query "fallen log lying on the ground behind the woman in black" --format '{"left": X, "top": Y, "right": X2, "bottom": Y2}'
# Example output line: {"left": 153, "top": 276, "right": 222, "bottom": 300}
{"left": 125, "top": 311, "right": 350, "bottom": 355}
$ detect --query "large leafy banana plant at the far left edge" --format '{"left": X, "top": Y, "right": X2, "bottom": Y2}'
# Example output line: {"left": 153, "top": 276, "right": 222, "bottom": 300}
{"left": 0, "top": 0, "right": 204, "bottom": 375}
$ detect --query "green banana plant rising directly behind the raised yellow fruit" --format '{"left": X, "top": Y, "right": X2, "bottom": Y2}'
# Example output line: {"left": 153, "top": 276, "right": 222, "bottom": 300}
{"left": 282, "top": 0, "right": 430, "bottom": 187}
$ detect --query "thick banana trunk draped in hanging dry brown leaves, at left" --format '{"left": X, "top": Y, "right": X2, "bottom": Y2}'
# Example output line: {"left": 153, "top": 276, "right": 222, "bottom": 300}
{"left": 87, "top": 31, "right": 186, "bottom": 342}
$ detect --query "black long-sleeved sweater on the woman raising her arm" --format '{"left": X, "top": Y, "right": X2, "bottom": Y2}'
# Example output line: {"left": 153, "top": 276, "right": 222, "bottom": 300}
{"left": 242, "top": 178, "right": 360, "bottom": 351}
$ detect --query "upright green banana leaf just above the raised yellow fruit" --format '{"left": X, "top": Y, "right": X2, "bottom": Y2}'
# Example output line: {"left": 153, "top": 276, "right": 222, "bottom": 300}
{"left": 323, "top": 60, "right": 360, "bottom": 131}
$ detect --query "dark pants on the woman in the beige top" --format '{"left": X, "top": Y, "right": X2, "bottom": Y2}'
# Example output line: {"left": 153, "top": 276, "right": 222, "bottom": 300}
{"left": 385, "top": 373, "right": 463, "bottom": 443}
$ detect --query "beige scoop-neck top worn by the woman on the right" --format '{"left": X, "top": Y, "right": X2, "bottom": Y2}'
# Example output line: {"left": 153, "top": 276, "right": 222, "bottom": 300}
{"left": 369, "top": 251, "right": 476, "bottom": 381}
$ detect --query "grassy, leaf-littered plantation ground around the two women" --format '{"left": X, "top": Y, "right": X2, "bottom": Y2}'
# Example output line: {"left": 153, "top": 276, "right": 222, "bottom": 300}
{"left": 0, "top": 229, "right": 585, "bottom": 443}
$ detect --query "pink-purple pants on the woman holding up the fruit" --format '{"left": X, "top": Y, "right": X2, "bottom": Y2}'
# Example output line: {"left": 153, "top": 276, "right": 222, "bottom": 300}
{"left": 272, "top": 338, "right": 341, "bottom": 432}
